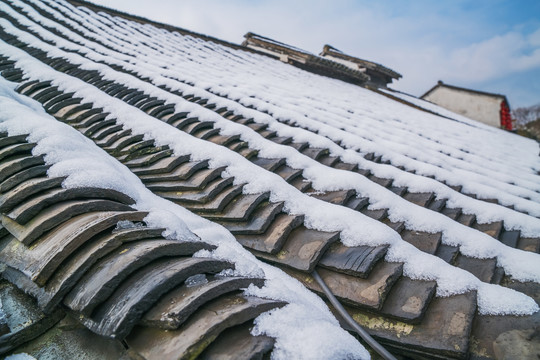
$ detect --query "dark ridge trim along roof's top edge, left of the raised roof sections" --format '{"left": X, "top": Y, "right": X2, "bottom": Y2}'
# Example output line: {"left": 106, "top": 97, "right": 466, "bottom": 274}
{"left": 66, "top": 0, "right": 260, "bottom": 54}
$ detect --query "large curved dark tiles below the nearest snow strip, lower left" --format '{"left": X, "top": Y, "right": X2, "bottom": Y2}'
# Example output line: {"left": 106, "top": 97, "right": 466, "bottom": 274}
{"left": 0, "top": 133, "right": 285, "bottom": 356}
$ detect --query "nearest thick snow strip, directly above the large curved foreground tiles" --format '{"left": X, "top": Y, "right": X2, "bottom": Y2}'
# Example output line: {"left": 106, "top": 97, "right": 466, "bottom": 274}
{"left": 0, "top": 77, "right": 369, "bottom": 359}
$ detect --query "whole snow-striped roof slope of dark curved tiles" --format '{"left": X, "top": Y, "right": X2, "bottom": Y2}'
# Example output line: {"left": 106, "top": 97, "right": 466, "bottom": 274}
{"left": 0, "top": 0, "right": 540, "bottom": 359}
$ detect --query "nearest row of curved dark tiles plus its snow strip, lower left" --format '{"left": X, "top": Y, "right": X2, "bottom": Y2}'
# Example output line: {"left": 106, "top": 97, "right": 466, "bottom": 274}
{"left": 0, "top": 74, "right": 367, "bottom": 359}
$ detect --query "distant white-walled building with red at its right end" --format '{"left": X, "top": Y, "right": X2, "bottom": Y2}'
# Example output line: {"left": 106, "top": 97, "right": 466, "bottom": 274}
{"left": 420, "top": 81, "right": 512, "bottom": 130}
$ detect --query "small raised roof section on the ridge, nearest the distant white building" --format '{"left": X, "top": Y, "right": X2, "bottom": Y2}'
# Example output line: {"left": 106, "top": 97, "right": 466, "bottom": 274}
{"left": 319, "top": 45, "right": 401, "bottom": 88}
